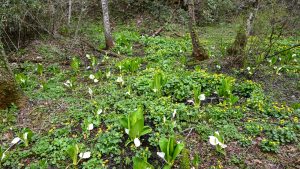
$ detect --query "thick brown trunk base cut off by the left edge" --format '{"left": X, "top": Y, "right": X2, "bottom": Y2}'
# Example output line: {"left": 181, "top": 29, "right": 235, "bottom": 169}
{"left": 0, "top": 41, "right": 21, "bottom": 109}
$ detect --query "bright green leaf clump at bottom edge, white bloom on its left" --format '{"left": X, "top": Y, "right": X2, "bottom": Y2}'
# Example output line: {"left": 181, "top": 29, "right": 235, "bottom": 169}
{"left": 157, "top": 136, "right": 184, "bottom": 169}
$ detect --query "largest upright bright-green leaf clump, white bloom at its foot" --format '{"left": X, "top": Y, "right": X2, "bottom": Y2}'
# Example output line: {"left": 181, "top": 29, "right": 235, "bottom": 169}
{"left": 120, "top": 106, "right": 152, "bottom": 147}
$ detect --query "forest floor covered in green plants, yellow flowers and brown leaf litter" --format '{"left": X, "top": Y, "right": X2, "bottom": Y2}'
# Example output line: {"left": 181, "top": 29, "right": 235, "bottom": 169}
{"left": 0, "top": 23, "right": 300, "bottom": 169}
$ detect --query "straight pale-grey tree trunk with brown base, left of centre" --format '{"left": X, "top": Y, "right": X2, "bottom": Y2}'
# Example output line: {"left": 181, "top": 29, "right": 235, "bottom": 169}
{"left": 101, "top": 0, "right": 114, "bottom": 49}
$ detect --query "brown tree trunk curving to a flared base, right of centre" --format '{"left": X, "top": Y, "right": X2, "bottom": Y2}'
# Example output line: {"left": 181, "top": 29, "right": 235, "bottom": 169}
{"left": 187, "top": 0, "right": 208, "bottom": 61}
